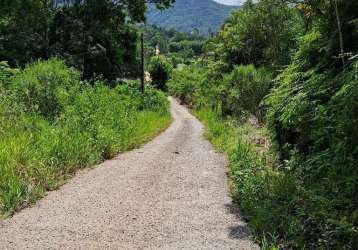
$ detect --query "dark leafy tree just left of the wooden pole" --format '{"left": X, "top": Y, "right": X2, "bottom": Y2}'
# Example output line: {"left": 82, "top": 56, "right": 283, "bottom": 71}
{"left": 51, "top": 1, "right": 137, "bottom": 80}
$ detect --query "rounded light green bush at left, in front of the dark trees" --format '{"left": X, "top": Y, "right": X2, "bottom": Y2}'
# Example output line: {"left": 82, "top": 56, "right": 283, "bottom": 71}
{"left": 10, "top": 59, "right": 80, "bottom": 120}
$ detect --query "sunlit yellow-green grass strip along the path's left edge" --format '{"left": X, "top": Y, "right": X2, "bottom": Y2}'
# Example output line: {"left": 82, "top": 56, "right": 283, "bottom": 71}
{"left": 0, "top": 111, "right": 171, "bottom": 215}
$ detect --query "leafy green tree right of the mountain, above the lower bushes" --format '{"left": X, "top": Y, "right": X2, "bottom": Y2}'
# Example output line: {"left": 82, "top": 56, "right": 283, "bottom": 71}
{"left": 206, "top": 0, "right": 303, "bottom": 69}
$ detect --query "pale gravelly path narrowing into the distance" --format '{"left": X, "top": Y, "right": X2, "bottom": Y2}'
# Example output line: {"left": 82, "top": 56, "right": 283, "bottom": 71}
{"left": 0, "top": 99, "right": 258, "bottom": 249}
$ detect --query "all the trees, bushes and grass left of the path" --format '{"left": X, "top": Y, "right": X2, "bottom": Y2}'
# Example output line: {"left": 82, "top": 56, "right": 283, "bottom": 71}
{"left": 0, "top": 0, "right": 173, "bottom": 216}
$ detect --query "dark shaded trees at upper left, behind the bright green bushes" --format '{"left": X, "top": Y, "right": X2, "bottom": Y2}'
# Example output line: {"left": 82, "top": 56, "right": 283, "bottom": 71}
{"left": 0, "top": 0, "right": 174, "bottom": 80}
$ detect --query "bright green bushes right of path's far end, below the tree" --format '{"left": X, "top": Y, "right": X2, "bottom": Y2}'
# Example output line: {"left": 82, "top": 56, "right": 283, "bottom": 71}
{"left": 168, "top": 63, "right": 272, "bottom": 121}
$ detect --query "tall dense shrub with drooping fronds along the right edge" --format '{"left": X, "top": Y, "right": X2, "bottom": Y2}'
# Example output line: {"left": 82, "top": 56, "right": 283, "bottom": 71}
{"left": 267, "top": 37, "right": 358, "bottom": 248}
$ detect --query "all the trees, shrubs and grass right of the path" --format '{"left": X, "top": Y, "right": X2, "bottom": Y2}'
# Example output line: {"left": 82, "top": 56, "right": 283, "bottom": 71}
{"left": 168, "top": 0, "right": 358, "bottom": 249}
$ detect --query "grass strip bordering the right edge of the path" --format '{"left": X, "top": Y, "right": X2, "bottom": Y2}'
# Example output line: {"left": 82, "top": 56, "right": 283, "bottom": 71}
{"left": 194, "top": 109, "right": 279, "bottom": 250}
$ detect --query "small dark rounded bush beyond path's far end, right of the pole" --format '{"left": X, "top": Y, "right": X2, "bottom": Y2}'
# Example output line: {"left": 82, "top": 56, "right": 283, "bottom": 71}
{"left": 149, "top": 56, "right": 172, "bottom": 91}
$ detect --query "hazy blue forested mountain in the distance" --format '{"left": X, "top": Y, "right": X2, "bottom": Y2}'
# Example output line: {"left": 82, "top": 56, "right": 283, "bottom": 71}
{"left": 146, "top": 0, "right": 239, "bottom": 35}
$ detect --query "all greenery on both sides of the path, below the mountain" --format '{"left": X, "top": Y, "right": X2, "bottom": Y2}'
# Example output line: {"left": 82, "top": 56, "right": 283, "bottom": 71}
{"left": 0, "top": 0, "right": 358, "bottom": 249}
